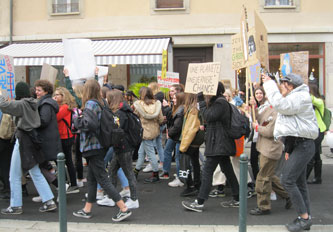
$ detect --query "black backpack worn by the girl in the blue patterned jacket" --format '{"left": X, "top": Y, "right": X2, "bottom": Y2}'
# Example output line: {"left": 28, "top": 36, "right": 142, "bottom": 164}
{"left": 92, "top": 99, "right": 125, "bottom": 148}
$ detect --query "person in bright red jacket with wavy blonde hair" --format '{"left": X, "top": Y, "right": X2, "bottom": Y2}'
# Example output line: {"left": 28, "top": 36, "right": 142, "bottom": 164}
{"left": 53, "top": 87, "right": 80, "bottom": 194}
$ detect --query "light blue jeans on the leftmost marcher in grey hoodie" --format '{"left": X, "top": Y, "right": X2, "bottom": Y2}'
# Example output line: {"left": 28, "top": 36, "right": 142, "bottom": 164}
{"left": 9, "top": 139, "right": 54, "bottom": 207}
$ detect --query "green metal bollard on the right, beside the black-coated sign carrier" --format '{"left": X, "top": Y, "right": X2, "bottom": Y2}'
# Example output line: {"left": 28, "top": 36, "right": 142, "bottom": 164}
{"left": 238, "top": 154, "right": 248, "bottom": 232}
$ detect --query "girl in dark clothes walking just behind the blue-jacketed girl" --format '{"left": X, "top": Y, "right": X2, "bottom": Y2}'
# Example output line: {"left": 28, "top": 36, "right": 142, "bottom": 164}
{"left": 106, "top": 89, "right": 141, "bottom": 209}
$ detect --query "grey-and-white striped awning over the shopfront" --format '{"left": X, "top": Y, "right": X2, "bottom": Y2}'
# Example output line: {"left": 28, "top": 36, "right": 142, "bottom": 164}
{"left": 0, "top": 38, "right": 170, "bottom": 66}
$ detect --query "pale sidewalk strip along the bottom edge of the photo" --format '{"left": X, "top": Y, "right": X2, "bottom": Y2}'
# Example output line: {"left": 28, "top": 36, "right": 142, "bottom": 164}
{"left": 0, "top": 220, "right": 333, "bottom": 232}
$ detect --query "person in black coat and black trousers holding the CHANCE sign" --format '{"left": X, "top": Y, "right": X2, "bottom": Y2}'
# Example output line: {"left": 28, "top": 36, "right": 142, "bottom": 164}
{"left": 182, "top": 82, "right": 239, "bottom": 212}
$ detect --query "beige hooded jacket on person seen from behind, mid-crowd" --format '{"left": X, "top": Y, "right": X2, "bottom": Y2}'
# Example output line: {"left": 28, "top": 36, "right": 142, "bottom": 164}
{"left": 134, "top": 100, "right": 163, "bottom": 140}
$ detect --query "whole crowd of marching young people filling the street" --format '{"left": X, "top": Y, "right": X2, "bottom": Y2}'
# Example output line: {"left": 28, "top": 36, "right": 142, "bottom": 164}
{"left": 0, "top": 69, "right": 329, "bottom": 231}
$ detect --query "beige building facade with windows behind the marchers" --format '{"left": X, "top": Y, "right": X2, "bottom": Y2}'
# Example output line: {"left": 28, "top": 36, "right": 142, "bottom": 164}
{"left": 0, "top": 0, "right": 333, "bottom": 107}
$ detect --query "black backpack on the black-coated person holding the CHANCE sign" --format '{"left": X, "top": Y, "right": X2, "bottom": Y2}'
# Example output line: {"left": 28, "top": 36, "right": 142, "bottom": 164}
{"left": 222, "top": 98, "right": 251, "bottom": 139}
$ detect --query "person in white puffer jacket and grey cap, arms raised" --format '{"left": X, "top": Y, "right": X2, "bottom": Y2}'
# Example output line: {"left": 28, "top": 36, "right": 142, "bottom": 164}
{"left": 262, "top": 73, "right": 319, "bottom": 232}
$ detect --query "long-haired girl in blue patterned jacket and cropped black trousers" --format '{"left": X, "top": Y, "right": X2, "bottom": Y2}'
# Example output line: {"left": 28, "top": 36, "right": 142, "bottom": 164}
{"left": 73, "top": 79, "right": 132, "bottom": 222}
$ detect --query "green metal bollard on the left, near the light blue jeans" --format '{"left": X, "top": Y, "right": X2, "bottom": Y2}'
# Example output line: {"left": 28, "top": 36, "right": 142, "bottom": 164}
{"left": 57, "top": 153, "right": 67, "bottom": 232}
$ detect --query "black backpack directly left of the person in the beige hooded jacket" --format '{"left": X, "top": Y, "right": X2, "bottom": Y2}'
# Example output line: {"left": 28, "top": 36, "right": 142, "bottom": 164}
{"left": 127, "top": 111, "right": 143, "bottom": 147}
